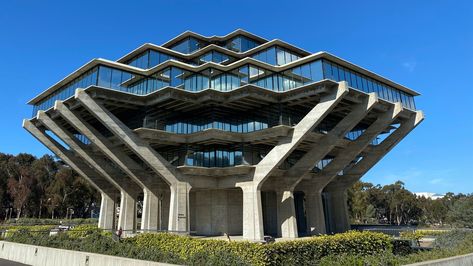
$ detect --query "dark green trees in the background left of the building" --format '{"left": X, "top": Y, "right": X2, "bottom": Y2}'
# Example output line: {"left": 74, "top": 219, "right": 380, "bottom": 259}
{"left": 0, "top": 153, "right": 98, "bottom": 220}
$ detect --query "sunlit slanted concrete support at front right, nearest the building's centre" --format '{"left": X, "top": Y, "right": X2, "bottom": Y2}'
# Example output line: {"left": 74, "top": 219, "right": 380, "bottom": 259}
{"left": 253, "top": 82, "right": 348, "bottom": 188}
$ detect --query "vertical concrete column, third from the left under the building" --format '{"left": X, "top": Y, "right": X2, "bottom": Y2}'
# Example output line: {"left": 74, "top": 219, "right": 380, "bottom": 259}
{"left": 141, "top": 189, "right": 159, "bottom": 232}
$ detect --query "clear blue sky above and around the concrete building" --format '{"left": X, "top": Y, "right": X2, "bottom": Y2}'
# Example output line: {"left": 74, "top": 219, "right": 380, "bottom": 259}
{"left": 0, "top": 0, "right": 473, "bottom": 193}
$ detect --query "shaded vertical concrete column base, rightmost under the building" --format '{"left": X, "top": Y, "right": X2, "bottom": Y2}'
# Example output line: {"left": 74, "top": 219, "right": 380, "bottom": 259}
{"left": 327, "top": 189, "right": 350, "bottom": 233}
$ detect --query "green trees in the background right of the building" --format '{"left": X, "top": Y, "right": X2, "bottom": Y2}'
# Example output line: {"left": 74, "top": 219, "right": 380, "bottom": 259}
{"left": 347, "top": 181, "right": 473, "bottom": 228}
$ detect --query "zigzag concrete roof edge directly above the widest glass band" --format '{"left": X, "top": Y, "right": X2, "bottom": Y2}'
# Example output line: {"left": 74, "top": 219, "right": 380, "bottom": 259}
{"left": 28, "top": 52, "right": 420, "bottom": 104}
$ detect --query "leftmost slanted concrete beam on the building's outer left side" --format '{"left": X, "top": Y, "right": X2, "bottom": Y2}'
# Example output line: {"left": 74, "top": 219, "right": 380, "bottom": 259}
{"left": 23, "top": 119, "right": 119, "bottom": 198}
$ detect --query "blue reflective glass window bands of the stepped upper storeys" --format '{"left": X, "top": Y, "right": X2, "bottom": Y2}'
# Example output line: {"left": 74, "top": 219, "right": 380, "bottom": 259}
{"left": 33, "top": 33, "right": 415, "bottom": 116}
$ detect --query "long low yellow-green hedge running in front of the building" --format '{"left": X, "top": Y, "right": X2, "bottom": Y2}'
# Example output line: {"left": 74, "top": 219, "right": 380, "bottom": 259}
{"left": 2, "top": 229, "right": 392, "bottom": 265}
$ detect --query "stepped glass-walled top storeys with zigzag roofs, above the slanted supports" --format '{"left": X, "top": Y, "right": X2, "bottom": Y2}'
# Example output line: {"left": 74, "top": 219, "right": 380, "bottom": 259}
{"left": 29, "top": 30, "right": 419, "bottom": 116}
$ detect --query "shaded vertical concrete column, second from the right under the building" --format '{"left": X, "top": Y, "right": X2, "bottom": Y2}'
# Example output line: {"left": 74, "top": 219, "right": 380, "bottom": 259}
{"left": 304, "top": 191, "right": 327, "bottom": 235}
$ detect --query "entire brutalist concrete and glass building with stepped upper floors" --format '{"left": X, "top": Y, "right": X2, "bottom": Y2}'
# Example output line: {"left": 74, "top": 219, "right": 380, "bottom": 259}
{"left": 23, "top": 30, "right": 423, "bottom": 240}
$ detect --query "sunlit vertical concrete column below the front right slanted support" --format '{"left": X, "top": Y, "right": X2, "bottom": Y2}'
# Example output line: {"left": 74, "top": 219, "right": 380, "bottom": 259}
{"left": 238, "top": 182, "right": 264, "bottom": 240}
